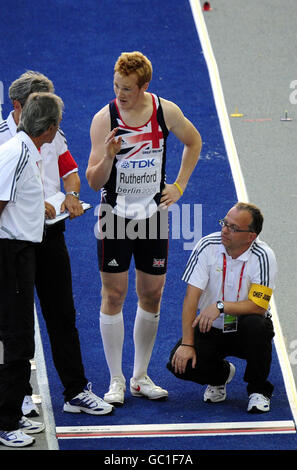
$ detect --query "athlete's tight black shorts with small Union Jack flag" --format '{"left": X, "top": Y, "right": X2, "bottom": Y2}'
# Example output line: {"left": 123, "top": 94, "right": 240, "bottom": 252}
{"left": 97, "top": 211, "right": 168, "bottom": 275}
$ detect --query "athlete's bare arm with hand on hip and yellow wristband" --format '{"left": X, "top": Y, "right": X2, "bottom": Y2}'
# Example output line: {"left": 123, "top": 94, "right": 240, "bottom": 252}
{"left": 161, "top": 99, "right": 202, "bottom": 206}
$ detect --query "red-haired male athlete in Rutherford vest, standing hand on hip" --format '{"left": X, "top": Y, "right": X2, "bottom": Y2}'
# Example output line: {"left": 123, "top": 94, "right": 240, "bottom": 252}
{"left": 86, "top": 52, "right": 201, "bottom": 405}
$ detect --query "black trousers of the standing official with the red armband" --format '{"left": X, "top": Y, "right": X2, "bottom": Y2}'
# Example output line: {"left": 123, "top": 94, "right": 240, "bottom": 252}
{"left": 35, "top": 231, "right": 88, "bottom": 402}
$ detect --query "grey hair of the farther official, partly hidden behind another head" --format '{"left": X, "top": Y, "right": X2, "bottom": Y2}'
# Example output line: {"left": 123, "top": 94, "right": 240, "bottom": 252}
{"left": 8, "top": 70, "right": 55, "bottom": 108}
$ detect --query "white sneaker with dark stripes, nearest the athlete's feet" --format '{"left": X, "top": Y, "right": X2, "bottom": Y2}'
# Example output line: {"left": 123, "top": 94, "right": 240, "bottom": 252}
{"left": 63, "top": 382, "right": 113, "bottom": 415}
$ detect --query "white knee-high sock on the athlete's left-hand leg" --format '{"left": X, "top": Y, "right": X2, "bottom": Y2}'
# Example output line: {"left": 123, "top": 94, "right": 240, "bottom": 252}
{"left": 100, "top": 311, "right": 124, "bottom": 379}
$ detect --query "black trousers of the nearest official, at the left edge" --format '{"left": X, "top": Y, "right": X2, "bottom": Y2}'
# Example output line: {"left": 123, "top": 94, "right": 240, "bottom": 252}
{"left": 0, "top": 240, "right": 35, "bottom": 431}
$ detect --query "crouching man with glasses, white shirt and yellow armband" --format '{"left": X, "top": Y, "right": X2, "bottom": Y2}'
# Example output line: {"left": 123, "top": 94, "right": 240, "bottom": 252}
{"left": 167, "top": 202, "right": 277, "bottom": 413}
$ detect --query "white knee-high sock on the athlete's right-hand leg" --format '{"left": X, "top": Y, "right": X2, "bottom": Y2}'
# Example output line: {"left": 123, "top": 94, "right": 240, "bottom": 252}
{"left": 133, "top": 306, "right": 160, "bottom": 379}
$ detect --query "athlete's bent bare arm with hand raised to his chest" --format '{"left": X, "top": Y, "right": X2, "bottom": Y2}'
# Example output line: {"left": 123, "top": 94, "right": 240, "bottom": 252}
{"left": 86, "top": 105, "right": 122, "bottom": 191}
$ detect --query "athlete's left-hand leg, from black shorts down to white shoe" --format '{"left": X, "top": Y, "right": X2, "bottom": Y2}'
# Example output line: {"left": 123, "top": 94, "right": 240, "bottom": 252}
{"left": 97, "top": 214, "right": 132, "bottom": 405}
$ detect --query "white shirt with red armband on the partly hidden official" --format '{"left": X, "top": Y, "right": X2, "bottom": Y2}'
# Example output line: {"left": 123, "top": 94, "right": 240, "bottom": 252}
{"left": 0, "top": 111, "right": 78, "bottom": 199}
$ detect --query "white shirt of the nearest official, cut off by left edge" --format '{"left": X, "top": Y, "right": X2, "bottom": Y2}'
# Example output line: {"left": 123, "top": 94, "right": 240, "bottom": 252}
{"left": 0, "top": 132, "right": 44, "bottom": 242}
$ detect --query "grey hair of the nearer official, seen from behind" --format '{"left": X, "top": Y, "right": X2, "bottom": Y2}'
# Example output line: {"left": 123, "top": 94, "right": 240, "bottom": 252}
{"left": 18, "top": 93, "right": 64, "bottom": 137}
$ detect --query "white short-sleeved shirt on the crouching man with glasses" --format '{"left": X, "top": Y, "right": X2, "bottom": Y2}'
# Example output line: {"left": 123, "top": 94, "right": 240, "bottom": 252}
{"left": 182, "top": 232, "right": 277, "bottom": 329}
